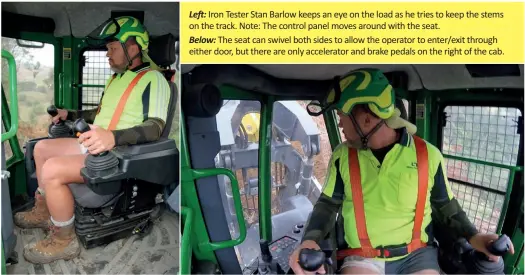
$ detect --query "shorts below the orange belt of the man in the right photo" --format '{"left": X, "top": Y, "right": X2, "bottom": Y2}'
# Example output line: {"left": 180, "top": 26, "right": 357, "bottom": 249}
{"left": 340, "top": 246, "right": 440, "bottom": 274}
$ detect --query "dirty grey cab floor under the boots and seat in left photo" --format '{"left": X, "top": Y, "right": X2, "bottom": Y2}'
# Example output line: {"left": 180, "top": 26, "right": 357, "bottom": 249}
{"left": 7, "top": 211, "right": 180, "bottom": 274}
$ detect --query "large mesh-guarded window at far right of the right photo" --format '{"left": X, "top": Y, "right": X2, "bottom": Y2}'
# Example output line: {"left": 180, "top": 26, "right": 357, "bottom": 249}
{"left": 442, "top": 106, "right": 521, "bottom": 233}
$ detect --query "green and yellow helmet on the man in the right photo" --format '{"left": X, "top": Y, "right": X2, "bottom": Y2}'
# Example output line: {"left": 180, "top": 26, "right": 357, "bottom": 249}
{"left": 307, "top": 69, "right": 395, "bottom": 119}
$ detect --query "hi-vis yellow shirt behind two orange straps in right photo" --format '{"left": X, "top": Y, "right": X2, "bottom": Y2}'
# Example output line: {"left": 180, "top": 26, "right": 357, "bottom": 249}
{"left": 323, "top": 130, "right": 453, "bottom": 261}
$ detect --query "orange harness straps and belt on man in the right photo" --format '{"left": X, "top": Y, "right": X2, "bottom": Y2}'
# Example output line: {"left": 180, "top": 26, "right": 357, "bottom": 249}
{"left": 337, "top": 136, "right": 428, "bottom": 260}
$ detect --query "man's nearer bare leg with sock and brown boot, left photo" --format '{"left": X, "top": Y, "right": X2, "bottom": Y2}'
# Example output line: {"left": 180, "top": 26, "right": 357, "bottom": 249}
{"left": 24, "top": 155, "right": 87, "bottom": 264}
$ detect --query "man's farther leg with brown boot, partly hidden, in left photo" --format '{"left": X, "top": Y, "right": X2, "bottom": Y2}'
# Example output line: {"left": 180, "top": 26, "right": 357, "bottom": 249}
{"left": 14, "top": 138, "right": 83, "bottom": 229}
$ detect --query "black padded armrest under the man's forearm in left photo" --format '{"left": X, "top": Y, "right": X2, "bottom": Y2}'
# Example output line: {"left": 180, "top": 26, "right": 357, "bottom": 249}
{"left": 80, "top": 138, "right": 179, "bottom": 194}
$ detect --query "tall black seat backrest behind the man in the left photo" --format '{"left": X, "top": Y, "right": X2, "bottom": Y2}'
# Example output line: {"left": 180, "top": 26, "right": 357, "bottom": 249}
{"left": 148, "top": 33, "right": 178, "bottom": 138}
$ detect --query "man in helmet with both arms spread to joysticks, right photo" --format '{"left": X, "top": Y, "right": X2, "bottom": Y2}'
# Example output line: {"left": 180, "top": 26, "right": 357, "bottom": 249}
{"left": 289, "top": 69, "right": 514, "bottom": 274}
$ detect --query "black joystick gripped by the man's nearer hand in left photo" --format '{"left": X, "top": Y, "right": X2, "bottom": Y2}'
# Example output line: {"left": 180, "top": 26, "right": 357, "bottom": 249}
{"left": 73, "top": 118, "right": 118, "bottom": 177}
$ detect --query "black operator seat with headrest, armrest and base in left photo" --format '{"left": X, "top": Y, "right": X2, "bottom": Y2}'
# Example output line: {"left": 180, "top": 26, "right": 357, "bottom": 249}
{"left": 22, "top": 34, "right": 179, "bottom": 249}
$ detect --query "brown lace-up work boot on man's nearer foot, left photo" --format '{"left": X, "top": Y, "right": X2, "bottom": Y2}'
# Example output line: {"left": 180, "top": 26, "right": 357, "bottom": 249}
{"left": 24, "top": 224, "right": 80, "bottom": 264}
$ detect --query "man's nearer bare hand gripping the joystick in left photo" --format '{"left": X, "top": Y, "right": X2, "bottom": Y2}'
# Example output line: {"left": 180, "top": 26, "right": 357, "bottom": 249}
{"left": 78, "top": 124, "right": 115, "bottom": 155}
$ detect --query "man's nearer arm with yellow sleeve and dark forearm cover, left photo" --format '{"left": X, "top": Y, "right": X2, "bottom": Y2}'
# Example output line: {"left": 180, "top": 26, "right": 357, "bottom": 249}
{"left": 112, "top": 71, "right": 171, "bottom": 146}
